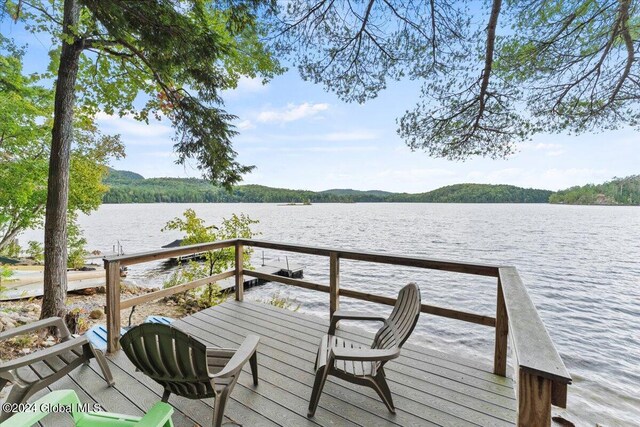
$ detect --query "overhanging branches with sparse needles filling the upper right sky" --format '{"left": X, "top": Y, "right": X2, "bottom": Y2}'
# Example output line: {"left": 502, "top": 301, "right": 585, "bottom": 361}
{"left": 279, "top": 0, "right": 640, "bottom": 160}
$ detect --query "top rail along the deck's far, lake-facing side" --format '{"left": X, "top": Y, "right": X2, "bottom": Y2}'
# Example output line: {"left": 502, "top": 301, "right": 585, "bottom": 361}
{"left": 239, "top": 239, "right": 500, "bottom": 277}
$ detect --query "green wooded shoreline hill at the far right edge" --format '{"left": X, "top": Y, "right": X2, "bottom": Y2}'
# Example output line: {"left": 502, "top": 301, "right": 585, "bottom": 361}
{"left": 549, "top": 175, "right": 640, "bottom": 206}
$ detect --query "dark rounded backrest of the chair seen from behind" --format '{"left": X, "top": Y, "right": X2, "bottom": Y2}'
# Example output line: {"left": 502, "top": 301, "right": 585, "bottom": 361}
{"left": 120, "top": 323, "right": 215, "bottom": 401}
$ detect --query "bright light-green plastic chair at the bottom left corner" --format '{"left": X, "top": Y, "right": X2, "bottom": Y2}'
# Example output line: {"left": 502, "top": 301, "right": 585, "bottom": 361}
{"left": 0, "top": 390, "right": 173, "bottom": 427}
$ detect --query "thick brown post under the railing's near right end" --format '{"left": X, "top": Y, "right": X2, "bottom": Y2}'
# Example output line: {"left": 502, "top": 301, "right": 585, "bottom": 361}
{"left": 516, "top": 368, "right": 552, "bottom": 427}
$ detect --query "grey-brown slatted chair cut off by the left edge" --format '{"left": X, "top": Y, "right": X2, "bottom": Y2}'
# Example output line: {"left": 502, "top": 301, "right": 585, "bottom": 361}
{"left": 0, "top": 317, "right": 114, "bottom": 421}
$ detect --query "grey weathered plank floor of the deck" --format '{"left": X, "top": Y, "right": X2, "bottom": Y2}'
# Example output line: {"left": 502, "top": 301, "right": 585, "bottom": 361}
{"left": 25, "top": 301, "right": 516, "bottom": 426}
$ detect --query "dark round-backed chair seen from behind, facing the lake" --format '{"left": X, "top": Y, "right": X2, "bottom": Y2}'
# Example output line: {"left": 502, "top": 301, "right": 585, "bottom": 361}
{"left": 120, "top": 323, "right": 260, "bottom": 427}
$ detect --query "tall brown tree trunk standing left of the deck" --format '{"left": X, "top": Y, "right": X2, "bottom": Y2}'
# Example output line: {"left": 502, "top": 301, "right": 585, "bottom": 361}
{"left": 40, "top": 0, "right": 82, "bottom": 319}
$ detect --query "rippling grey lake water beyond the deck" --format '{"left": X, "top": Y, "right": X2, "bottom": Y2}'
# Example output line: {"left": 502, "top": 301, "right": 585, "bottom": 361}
{"left": 21, "top": 204, "right": 640, "bottom": 426}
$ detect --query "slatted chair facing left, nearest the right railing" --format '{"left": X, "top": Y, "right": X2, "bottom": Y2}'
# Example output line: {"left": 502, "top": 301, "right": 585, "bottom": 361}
{"left": 307, "top": 283, "right": 421, "bottom": 417}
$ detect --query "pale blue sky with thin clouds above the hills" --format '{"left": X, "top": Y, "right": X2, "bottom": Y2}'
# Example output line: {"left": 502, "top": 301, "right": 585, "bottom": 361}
{"left": 6, "top": 15, "right": 640, "bottom": 193}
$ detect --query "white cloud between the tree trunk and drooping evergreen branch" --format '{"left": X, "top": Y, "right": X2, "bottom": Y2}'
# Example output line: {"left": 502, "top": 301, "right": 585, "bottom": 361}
{"left": 96, "top": 112, "right": 173, "bottom": 140}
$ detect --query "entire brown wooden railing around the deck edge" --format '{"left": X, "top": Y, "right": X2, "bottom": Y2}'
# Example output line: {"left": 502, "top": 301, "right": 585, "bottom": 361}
{"left": 104, "top": 239, "right": 571, "bottom": 426}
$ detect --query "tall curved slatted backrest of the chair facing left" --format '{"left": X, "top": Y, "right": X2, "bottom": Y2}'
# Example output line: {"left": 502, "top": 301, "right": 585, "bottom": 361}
{"left": 371, "top": 283, "right": 421, "bottom": 349}
